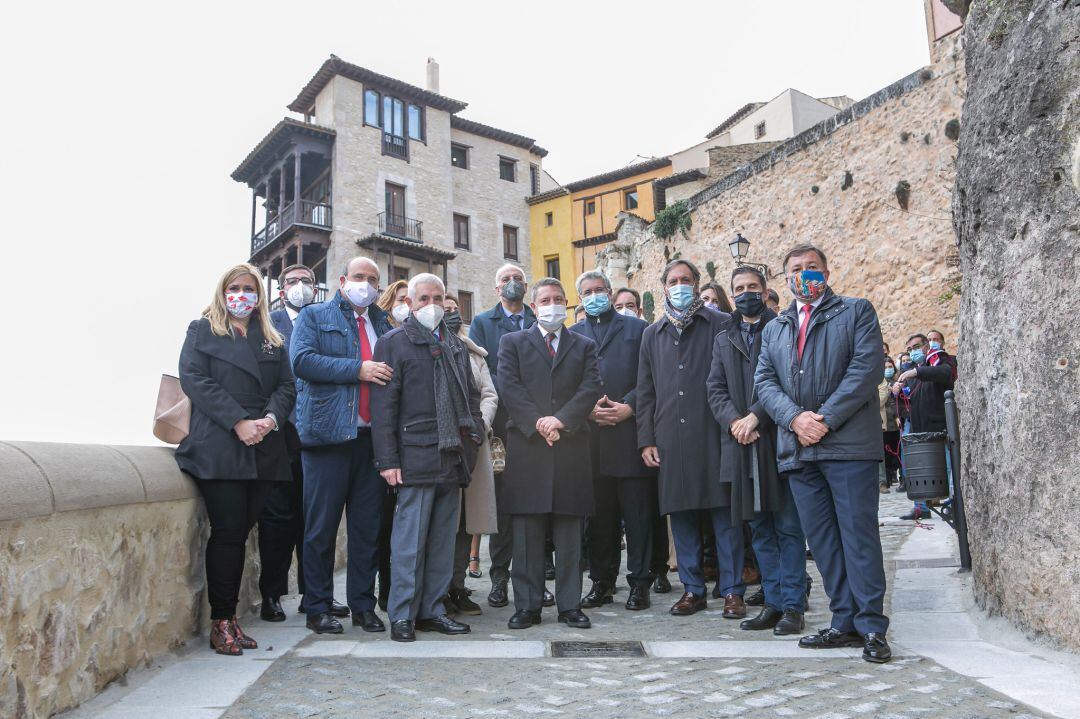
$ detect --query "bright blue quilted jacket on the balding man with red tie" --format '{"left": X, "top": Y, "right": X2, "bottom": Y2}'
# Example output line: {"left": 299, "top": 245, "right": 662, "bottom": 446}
{"left": 289, "top": 293, "right": 391, "bottom": 447}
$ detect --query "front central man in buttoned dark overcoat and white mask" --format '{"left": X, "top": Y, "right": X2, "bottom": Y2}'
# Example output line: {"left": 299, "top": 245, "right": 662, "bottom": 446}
{"left": 499, "top": 277, "right": 602, "bottom": 629}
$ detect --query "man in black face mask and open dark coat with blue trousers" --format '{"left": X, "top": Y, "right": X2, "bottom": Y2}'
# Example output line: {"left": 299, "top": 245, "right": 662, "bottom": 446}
{"left": 707, "top": 266, "right": 807, "bottom": 635}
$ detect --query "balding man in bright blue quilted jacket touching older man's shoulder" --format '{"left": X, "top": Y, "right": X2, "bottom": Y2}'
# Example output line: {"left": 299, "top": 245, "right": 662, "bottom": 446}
{"left": 291, "top": 257, "right": 393, "bottom": 634}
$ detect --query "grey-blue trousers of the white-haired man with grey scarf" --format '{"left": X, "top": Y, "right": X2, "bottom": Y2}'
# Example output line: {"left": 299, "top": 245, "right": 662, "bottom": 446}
{"left": 387, "top": 484, "right": 461, "bottom": 622}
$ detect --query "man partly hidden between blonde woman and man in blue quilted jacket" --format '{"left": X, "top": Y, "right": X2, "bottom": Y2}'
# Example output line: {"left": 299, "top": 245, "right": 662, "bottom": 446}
{"left": 259, "top": 264, "right": 349, "bottom": 622}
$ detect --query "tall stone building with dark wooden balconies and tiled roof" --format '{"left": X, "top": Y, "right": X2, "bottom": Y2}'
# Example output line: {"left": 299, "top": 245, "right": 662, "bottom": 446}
{"left": 232, "top": 55, "right": 554, "bottom": 322}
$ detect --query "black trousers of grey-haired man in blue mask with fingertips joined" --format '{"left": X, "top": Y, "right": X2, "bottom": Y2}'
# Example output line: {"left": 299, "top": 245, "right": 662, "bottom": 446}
{"left": 585, "top": 475, "right": 652, "bottom": 586}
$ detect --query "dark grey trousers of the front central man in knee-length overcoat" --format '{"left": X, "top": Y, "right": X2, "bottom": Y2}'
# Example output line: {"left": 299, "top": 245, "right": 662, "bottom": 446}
{"left": 510, "top": 514, "right": 585, "bottom": 612}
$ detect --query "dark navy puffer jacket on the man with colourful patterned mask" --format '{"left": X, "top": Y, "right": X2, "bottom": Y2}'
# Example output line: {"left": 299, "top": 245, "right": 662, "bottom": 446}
{"left": 754, "top": 289, "right": 883, "bottom": 472}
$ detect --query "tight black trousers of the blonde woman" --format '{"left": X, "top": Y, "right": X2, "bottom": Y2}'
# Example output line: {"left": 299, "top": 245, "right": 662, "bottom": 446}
{"left": 195, "top": 479, "right": 282, "bottom": 620}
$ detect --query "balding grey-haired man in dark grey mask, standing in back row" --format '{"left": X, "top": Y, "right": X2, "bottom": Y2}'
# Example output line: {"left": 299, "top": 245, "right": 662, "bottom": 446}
{"left": 469, "top": 263, "right": 537, "bottom": 607}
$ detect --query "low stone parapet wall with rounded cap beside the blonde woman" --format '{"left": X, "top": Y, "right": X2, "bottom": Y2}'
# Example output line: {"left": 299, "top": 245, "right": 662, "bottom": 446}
{"left": 0, "top": 442, "right": 345, "bottom": 719}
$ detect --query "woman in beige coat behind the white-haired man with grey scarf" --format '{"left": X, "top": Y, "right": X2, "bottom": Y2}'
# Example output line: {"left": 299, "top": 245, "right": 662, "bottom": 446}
{"left": 443, "top": 295, "right": 499, "bottom": 614}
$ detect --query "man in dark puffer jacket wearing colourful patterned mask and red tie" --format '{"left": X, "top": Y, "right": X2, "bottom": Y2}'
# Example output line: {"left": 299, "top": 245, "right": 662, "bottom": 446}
{"left": 754, "top": 245, "right": 892, "bottom": 663}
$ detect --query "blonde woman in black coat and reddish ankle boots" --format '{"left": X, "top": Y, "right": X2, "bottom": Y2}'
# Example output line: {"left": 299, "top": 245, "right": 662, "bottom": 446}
{"left": 176, "top": 264, "right": 296, "bottom": 655}
